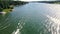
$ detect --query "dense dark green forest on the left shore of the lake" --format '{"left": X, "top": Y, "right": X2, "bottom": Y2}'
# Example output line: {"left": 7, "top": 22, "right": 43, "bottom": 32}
{"left": 0, "top": 1, "right": 28, "bottom": 12}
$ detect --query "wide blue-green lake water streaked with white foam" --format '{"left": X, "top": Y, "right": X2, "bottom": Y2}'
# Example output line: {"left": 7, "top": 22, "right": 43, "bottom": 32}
{"left": 0, "top": 3, "right": 60, "bottom": 34}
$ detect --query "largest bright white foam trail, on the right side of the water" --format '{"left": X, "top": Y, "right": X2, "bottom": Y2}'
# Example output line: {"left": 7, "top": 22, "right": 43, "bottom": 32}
{"left": 46, "top": 15, "right": 60, "bottom": 34}
